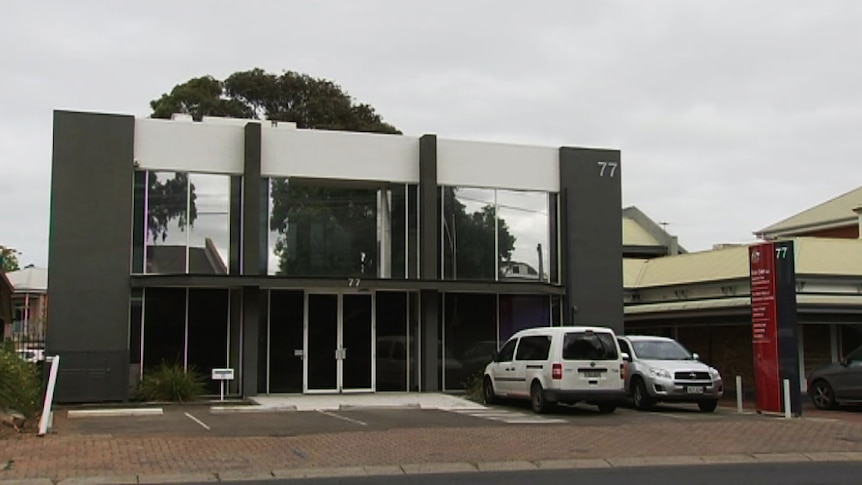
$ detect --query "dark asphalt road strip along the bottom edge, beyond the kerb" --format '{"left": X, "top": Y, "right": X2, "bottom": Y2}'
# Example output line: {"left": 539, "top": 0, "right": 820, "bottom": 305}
{"left": 199, "top": 462, "right": 862, "bottom": 485}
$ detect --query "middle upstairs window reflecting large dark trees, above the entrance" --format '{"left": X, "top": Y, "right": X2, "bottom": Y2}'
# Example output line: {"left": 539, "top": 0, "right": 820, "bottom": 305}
{"left": 268, "top": 178, "right": 416, "bottom": 278}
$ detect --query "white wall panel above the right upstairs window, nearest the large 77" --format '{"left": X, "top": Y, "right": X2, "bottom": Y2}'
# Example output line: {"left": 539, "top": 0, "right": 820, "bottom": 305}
{"left": 437, "top": 138, "right": 560, "bottom": 192}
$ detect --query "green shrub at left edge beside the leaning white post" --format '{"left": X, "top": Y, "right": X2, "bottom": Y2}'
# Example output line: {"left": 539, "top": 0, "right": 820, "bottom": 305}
{"left": 0, "top": 345, "right": 42, "bottom": 419}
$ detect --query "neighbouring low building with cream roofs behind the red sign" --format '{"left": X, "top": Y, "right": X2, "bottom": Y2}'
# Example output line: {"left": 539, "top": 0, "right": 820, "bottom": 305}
{"left": 623, "top": 184, "right": 862, "bottom": 394}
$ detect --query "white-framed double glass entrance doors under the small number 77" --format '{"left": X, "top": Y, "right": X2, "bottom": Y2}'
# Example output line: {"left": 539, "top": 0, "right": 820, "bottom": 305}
{"left": 304, "top": 293, "right": 374, "bottom": 393}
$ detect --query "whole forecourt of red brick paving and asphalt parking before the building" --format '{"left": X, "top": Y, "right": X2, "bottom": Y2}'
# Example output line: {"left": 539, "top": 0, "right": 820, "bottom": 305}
{"left": 0, "top": 396, "right": 862, "bottom": 483}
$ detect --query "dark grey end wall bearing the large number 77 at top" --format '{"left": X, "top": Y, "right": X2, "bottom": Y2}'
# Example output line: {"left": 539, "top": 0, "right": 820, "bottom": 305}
{"left": 560, "top": 147, "right": 623, "bottom": 332}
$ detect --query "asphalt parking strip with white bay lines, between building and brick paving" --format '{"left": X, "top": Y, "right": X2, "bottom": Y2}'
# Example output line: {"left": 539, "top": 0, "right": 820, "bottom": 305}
{"left": 60, "top": 398, "right": 764, "bottom": 437}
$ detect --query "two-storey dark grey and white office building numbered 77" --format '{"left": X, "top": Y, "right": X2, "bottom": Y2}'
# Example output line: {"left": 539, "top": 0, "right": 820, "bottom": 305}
{"left": 47, "top": 111, "right": 623, "bottom": 402}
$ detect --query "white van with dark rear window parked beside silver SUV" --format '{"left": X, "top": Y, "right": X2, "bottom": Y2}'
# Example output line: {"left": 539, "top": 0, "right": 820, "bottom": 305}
{"left": 483, "top": 327, "right": 625, "bottom": 413}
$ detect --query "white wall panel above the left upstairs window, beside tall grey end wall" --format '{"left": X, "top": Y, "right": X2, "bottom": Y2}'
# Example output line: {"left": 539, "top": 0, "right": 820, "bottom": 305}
{"left": 135, "top": 118, "right": 247, "bottom": 174}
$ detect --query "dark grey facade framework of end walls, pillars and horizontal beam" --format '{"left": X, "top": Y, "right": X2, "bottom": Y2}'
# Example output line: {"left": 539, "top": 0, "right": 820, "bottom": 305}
{"left": 48, "top": 111, "right": 623, "bottom": 401}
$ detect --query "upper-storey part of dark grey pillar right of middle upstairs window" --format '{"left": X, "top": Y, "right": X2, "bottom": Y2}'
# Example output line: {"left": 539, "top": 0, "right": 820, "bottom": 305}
{"left": 419, "top": 135, "right": 440, "bottom": 279}
